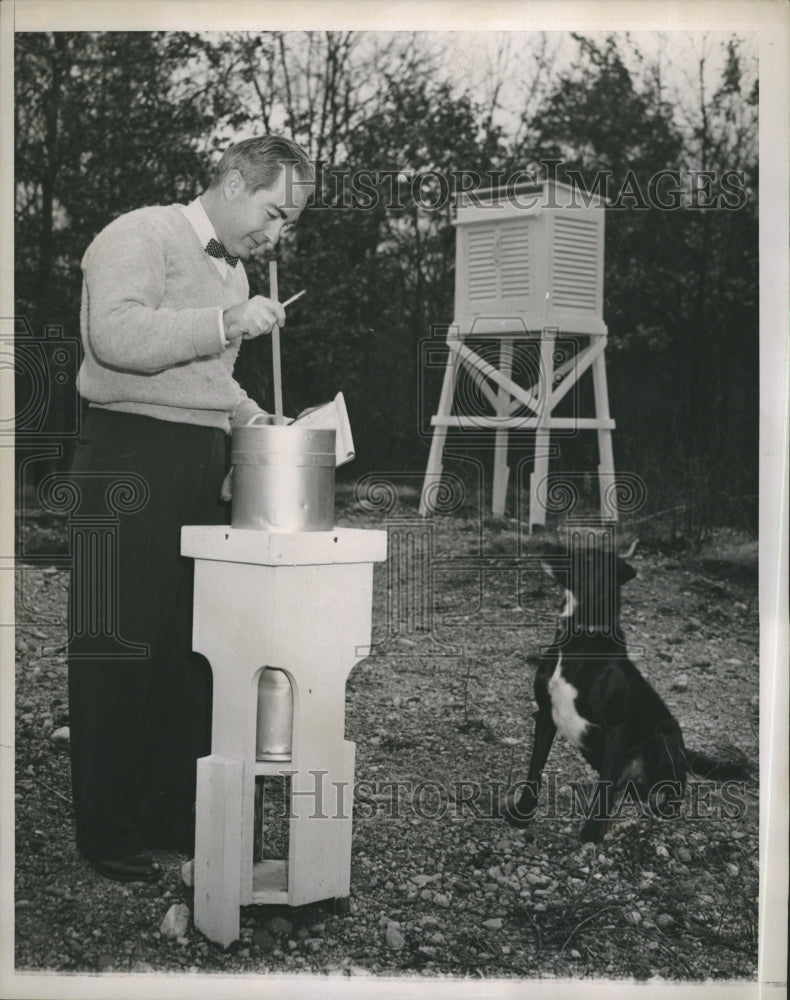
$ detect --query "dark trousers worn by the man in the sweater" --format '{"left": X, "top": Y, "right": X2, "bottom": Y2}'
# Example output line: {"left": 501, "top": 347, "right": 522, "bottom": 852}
{"left": 69, "top": 409, "right": 228, "bottom": 859}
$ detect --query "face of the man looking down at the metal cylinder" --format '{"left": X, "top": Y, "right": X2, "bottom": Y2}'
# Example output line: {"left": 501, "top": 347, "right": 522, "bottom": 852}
{"left": 220, "top": 167, "right": 312, "bottom": 260}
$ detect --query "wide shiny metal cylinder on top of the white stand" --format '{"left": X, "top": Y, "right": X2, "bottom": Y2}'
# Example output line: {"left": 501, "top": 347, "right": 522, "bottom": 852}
{"left": 231, "top": 424, "right": 335, "bottom": 532}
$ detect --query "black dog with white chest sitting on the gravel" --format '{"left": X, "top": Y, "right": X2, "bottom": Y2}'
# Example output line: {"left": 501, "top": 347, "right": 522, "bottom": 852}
{"left": 505, "top": 538, "right": 749, "bottom": 842}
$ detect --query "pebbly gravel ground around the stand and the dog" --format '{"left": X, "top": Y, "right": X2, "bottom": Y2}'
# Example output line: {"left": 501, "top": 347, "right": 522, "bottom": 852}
{"left": 9, "top": 507, "right": 759, "bottom": 981}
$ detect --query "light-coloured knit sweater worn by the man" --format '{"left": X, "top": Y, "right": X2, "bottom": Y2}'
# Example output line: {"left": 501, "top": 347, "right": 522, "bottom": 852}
{"left": 77, "top": 205, "right": 260, "bottom": 433}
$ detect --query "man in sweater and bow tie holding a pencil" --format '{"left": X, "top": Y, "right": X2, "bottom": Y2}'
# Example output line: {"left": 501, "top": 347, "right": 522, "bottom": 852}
{"left": 69, "top": 136, "right": 313, "bottom": 881}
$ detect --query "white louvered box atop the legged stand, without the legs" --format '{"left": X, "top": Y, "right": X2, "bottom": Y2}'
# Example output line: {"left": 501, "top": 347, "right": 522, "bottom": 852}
{"left": 453, "top": 181, "right": 606, "bottom": 336}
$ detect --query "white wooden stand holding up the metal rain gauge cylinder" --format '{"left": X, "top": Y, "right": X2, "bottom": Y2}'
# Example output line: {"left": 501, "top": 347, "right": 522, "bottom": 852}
{"left": 181, "top": 525, "right": 387, "bottom": 947}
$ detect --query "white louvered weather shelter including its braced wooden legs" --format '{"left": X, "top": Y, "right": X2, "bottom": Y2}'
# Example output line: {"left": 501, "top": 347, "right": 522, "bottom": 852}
{"left": 420, "top": 180, "right": 617, "bottom": 528}
